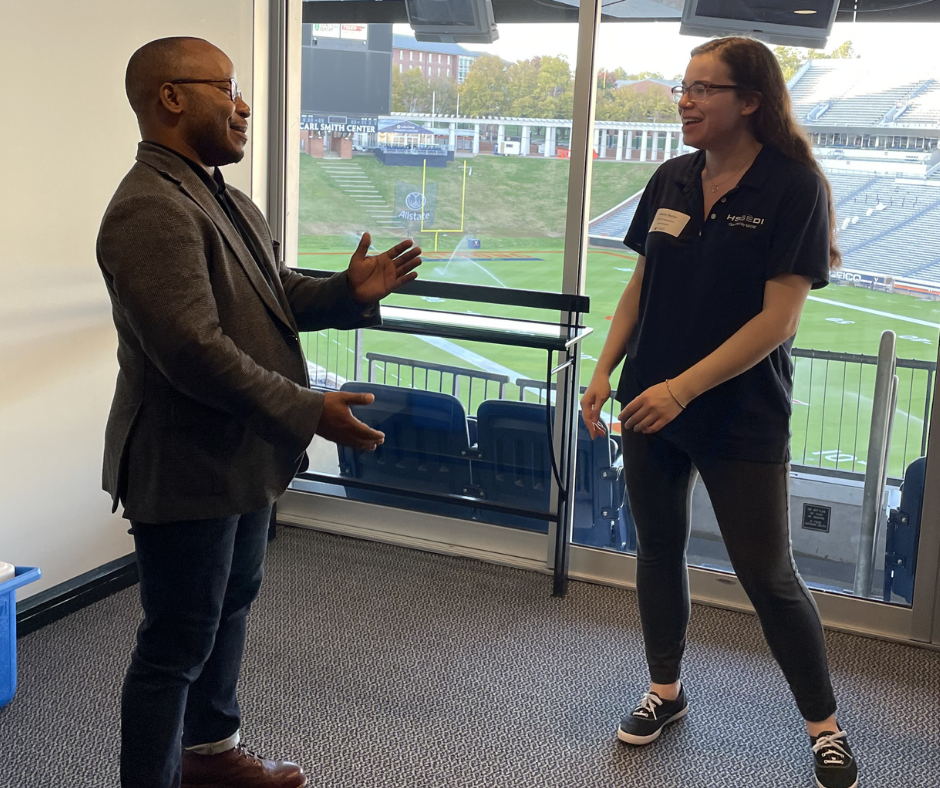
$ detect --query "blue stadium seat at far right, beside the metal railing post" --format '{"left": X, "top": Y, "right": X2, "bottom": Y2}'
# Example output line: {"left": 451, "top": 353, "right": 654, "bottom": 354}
{"left": 884, "top": 457, "right": 927, "bottom": 604}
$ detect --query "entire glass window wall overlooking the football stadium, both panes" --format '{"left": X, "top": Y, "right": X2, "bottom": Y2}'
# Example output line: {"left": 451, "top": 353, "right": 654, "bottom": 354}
{"left": 289, "top": 4, "right": 940, "bottom": 636}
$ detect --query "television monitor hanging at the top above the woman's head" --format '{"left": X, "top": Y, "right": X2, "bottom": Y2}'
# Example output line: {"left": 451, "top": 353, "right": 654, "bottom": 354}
{"left": 679, "top": 0, "right": 839, "bottom": 49}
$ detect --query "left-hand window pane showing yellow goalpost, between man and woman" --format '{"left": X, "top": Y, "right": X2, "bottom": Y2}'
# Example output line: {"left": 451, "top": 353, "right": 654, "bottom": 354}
{"left": 296, "top": 16, "right": 577, "bottom": 536}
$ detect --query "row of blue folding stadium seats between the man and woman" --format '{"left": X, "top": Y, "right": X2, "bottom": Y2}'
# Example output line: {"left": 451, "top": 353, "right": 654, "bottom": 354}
{"left": 339, "top": 382, "right": 635, "bottom": 550}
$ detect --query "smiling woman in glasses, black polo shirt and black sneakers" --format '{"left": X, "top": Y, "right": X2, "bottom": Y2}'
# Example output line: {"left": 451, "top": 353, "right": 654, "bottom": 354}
{"left": 581, "top": 37, "right": 857, "bottom": 788}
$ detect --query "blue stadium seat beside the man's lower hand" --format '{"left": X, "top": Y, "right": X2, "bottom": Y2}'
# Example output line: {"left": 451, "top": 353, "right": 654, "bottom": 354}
{"left": 337, "top": 382, "right": 475, "bottom": 518}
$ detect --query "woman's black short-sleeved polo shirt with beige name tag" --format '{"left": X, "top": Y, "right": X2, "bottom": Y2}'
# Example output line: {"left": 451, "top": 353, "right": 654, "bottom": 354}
{"left": 617, "top": 145, "right": 829, "bottom": 462}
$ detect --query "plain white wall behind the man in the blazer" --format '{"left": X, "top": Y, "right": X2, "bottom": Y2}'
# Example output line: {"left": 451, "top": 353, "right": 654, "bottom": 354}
{"left": 0, "top": 0, "right": 267, "bottom": 599}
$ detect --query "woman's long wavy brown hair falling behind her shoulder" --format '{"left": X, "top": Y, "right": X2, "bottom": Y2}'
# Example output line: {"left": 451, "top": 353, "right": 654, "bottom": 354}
{"left": 692, "top": 36, "right": 842, "bottom": 268}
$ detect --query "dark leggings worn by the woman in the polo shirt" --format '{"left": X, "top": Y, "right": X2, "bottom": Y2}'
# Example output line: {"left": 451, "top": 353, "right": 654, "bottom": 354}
{"left": 623, "top": 432, "right": 836, "bottom": 722}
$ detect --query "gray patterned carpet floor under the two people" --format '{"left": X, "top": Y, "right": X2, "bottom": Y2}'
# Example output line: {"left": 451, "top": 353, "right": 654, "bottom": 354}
{"left": 0, "top": 528, "right": 940, "bottom": 788}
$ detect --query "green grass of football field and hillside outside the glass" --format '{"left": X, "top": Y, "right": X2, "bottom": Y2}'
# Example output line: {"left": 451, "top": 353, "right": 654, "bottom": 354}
{"left": 299, "top": 151, "right": 940, "bottom": 477}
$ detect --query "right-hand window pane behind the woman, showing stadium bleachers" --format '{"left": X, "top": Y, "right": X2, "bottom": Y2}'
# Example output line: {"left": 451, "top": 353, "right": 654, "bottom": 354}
{"left": 582, "top": 18, "right": 940, "bottom": 605}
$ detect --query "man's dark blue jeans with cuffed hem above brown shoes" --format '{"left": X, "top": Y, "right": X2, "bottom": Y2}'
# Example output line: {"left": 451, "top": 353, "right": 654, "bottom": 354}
{"left": 121, "top": 507, "right": 271, "bottom": 788}
